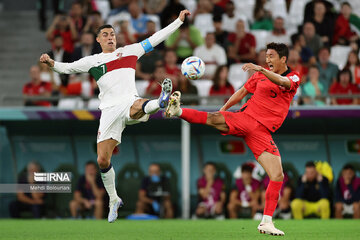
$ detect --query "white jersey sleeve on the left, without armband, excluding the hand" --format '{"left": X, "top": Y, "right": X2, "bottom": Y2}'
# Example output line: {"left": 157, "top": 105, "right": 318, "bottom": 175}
{"left": 53, "top": 56, "right": 91, "bottom": 74}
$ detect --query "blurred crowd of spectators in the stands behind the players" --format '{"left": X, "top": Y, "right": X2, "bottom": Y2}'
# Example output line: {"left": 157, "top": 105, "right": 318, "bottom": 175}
{"left": 23, "top": 0, "right": 360, "bottom": 106}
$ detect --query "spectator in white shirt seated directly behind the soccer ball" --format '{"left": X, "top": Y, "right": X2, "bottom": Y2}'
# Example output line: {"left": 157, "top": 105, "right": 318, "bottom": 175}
{"left": 194, "top": 32, "right": 227, "bottom": 79}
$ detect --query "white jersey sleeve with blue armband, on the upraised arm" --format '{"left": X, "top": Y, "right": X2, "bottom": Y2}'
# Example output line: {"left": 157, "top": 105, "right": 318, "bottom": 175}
{"left": 125, "top": 18, "right": 183, "bottom": 58}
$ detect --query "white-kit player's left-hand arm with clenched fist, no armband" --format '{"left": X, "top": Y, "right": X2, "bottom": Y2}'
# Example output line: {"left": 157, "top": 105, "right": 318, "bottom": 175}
{"left": 40, "top": 54, "right": 91, "bottom": 74}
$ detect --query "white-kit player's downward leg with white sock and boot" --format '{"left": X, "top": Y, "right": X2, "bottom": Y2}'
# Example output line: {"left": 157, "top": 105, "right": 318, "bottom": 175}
{"left": 97, "top": 139, "right": 124, "bottom": 223}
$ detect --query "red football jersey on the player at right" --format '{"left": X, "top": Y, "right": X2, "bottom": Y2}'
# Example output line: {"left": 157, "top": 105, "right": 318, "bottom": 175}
{"left": 242, "top": 68, "right": 300, "bottom": 132}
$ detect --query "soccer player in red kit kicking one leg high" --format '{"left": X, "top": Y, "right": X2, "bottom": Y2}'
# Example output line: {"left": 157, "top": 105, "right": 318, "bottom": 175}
{"left": 166, "top": 43, "right": 300, "bottom": 235}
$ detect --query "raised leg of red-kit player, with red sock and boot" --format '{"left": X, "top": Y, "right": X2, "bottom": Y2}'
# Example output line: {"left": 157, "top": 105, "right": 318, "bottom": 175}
{"left": 165, "top": 91, "right": 229, "bottom": 132}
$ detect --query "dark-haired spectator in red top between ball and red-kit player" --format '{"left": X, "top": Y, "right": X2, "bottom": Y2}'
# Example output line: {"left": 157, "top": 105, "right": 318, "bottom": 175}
{"left": 209, "top": 65, "right": 235, "bottom": 102}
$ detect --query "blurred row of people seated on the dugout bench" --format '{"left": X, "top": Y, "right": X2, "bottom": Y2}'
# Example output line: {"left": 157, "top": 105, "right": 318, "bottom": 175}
{"left": 9, "top": 161, "right": 360, "bottom": 220}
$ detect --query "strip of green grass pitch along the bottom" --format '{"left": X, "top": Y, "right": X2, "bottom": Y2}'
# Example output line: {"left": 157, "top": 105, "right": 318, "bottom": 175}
{"left": 0, "top": 219, "right": 360, "bottom": 240}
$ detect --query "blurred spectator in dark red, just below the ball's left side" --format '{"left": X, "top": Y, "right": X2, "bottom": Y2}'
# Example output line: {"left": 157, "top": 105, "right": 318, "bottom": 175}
{"left": 176, "top": 74, "right": 199, "bottom": 105}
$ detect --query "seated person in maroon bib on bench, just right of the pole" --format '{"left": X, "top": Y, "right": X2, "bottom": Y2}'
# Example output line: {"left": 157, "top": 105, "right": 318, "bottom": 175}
{"left": 196, "top": 162, "right": 226, "bottom": 217}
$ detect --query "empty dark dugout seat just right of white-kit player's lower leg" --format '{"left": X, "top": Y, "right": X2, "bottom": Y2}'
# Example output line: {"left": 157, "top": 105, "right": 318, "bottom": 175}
{"left": 116, "top": 163, "right": 144, "bottom": 217}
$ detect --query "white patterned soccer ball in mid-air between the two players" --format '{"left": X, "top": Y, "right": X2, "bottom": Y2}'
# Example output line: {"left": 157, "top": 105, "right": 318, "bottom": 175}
{"left": 181, "top": 56, "right": 205, "bottom": 80}
